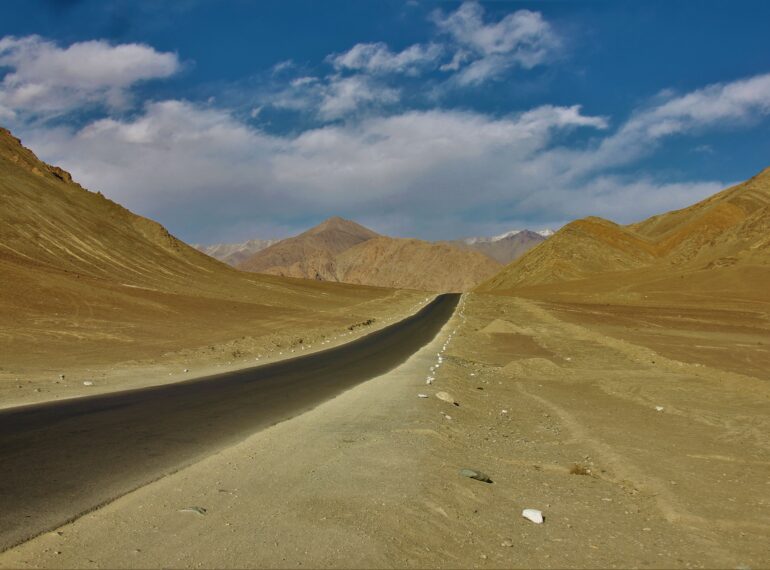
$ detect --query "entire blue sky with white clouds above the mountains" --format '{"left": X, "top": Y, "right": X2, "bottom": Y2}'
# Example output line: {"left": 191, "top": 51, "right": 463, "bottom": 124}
{"left": 0, "top": 0, "right": 770, "bottom": 243}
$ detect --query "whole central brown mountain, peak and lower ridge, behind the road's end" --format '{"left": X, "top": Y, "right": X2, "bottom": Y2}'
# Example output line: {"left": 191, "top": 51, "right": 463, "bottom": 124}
{"left": 238, "top": 217, "right": 500, "bottom": 291}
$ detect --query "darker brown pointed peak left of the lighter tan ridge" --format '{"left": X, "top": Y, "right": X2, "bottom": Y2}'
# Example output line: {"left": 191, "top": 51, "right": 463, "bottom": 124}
{"left": 238, "top": 217, "right": 379, "bottom": 281}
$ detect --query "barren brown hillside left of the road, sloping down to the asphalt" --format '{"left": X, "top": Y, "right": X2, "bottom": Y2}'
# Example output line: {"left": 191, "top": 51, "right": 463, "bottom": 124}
{"left": 0, "top": 130, "right": 423, "bottom": 402}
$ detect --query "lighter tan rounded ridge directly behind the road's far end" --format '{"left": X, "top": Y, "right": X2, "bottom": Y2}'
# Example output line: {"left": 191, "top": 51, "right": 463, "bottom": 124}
{"left": 336, "top": 237, "right": 500, "bottom": 291}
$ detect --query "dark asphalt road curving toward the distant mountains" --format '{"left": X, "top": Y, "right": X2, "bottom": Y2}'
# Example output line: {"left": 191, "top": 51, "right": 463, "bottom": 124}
{"left": 0, "top": 295, "right": 459, "bottom": 550}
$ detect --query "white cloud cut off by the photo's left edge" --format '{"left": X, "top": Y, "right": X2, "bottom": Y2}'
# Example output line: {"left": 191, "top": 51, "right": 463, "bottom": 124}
{"left": 0, "top": 36, "right": 180, "bottom": 114}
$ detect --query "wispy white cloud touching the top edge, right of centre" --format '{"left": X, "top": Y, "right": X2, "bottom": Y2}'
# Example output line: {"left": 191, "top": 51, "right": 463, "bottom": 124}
{"left": 433, "top": 2, "right": 561, "bottom": 85}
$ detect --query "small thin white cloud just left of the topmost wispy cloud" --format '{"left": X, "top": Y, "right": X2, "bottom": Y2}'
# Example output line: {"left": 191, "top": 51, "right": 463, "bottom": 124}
{"left": 327, "top": 42, "right": 443, "bottom": 75}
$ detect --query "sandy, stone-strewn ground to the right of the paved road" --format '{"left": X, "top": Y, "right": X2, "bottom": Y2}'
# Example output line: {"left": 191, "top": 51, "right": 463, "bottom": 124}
{"left": 0, "top": 295, "right": 770, "bottom": 568}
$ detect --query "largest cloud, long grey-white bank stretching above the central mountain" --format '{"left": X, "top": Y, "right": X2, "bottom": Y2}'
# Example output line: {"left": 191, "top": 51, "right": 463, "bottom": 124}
{"left": 27, "top": 97, "right": 605, "bottom": 239}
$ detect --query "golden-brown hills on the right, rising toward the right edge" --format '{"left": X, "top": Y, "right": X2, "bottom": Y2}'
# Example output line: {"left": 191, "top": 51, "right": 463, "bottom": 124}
{"left": 478, "top": 169, "right": 770, "bottom": 302}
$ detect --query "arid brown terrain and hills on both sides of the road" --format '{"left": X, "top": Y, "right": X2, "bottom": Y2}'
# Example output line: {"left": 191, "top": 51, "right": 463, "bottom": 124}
{"left": 0, "top": 125, "right": 770, "bottom": 568}
